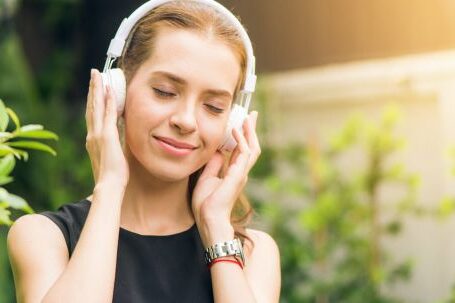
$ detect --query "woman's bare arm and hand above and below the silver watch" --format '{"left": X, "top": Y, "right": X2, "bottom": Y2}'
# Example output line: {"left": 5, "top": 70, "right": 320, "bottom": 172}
{"left": 192, "top": 112, "right": 281, "bottom": 303}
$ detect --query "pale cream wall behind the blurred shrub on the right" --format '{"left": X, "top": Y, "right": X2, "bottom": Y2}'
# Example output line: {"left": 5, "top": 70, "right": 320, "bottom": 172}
{"left": 262, "top": 52, "right": 455, "bottom": 302}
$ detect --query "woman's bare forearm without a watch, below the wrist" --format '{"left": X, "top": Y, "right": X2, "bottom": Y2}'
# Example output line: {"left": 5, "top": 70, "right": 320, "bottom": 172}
{"left": 43, "top": 186, "right": 122, "bottom": 302}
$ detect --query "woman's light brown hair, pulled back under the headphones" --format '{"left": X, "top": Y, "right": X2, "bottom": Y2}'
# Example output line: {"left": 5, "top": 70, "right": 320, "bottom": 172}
{"left": 118, "top": 0, "right": 254, "bottom": 249}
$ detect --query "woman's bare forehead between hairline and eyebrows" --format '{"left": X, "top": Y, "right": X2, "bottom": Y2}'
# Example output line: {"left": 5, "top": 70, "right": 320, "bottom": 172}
{"left": 138, "top": 27, "right": 240, "bottom": 93}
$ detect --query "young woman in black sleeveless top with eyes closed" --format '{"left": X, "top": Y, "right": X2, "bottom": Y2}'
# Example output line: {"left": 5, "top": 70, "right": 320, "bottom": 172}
{"left": 8, "top": 0, "right": 281, "bottom": 303}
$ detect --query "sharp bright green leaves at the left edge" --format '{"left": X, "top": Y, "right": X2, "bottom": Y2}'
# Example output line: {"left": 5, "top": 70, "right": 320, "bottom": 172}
{"left": 0, "top": 99, "right": 58, "bottom": 225}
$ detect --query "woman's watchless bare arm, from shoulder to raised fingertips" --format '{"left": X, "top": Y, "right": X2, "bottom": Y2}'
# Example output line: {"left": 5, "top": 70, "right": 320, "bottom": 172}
{"left": 8, "top": 70, "right": 129, "bottom": 303}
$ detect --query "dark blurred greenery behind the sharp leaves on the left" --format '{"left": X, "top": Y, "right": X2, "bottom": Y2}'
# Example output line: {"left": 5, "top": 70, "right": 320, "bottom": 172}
{"left": 0, "top": 0, "right": 89, "bottom": 302}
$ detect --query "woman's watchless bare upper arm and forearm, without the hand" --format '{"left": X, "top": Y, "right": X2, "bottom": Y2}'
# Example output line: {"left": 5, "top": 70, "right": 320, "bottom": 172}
{"left": 8, "top": 186, "right": 121, "bottom": 303}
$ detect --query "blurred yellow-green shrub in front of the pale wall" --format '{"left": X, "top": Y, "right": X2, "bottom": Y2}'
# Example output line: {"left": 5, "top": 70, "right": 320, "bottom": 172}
{"left": 251, "top": 107, "right": 423, "bottom": 303}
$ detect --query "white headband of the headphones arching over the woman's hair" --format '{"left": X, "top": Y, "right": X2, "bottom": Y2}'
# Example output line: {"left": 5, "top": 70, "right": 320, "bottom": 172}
{"left": 104, "top": 0, "right": 256, "bottom": 93}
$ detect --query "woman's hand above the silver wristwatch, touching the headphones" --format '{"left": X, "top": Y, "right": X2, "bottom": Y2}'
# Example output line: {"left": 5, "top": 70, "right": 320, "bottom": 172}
{"left": 192, "top": 111, "right": 261, "bottom": 247}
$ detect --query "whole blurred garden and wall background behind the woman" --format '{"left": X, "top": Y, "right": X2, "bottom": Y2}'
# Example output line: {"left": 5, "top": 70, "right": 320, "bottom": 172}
{"left": 0, "top": 0, "right": 455, "bottom": 303}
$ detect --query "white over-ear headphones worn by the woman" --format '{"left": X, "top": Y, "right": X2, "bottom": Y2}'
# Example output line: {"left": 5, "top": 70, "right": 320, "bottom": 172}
{"left": 101, "top": 0, "right": 256, "bottom": 151}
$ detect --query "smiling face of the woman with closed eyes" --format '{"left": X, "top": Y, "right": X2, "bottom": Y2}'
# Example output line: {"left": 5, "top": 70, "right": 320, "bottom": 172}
{"left": 121, "top": 27, "right": 240, "bottom": 181}
